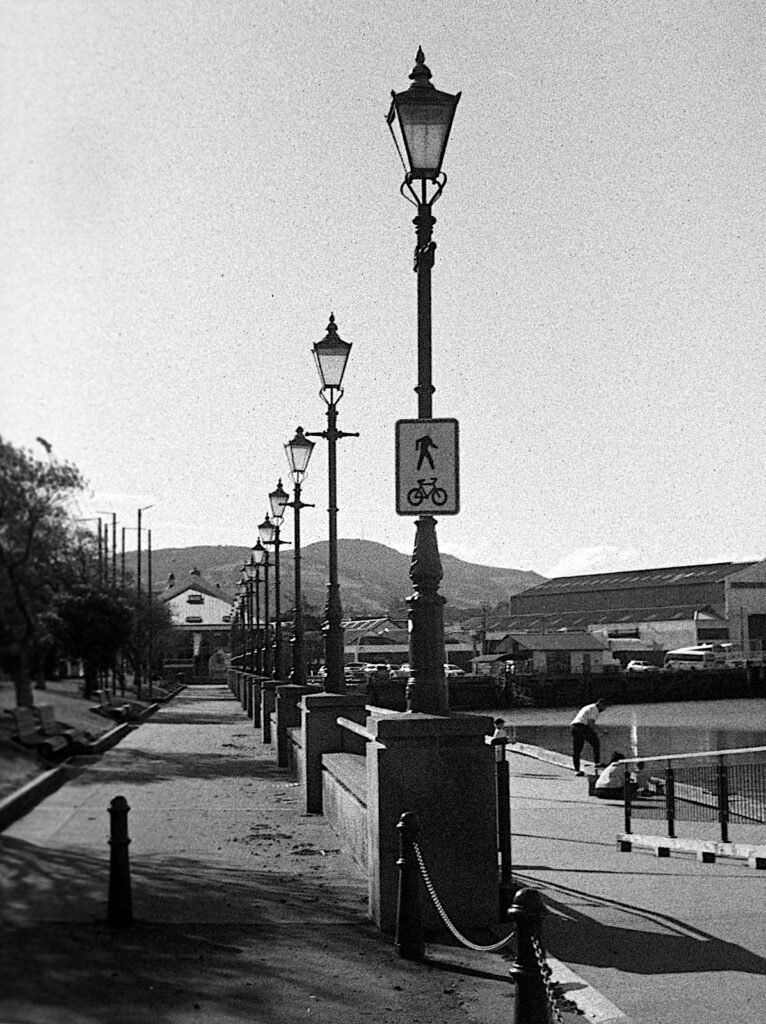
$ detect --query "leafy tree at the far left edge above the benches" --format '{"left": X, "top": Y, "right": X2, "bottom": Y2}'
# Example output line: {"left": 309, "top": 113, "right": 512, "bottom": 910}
{"left": 0, "top": 437, "right": 84, "bottom": 706}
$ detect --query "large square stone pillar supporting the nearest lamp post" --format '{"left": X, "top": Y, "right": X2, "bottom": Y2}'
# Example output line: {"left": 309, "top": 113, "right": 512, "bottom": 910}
{"left": 367, "top": 713, "right": 500, "bottom": 933}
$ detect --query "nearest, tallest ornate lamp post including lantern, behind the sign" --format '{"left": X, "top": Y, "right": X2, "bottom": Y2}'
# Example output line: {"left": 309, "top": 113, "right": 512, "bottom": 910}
{"left": 387, "top": 48, "right": 460, "bottom": 715}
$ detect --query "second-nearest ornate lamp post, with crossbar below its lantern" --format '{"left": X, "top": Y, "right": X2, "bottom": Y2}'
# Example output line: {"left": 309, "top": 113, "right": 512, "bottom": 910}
{"left": 308, "top": 313, "right": 359, "bottom": 693}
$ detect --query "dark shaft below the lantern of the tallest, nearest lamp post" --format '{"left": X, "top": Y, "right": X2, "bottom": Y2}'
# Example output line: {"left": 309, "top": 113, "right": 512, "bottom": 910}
{"left": 407, "top": 195, "right": 449, "bottom": 715}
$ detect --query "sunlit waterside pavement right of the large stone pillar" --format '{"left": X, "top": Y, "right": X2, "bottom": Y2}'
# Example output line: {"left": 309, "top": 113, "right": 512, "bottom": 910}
{"left": 510, "top": 755, "right": 766, "bottom": 1024}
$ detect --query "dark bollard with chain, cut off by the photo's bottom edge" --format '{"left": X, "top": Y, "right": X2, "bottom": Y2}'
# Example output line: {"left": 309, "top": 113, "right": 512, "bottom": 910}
{"left": 508, "top": 889, "right": 550, "bottom": 1024}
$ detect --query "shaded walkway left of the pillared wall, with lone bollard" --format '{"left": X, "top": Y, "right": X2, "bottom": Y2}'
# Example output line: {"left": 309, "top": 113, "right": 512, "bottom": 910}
{"left": 0, "top": 687, "right": 575, "bottom": 1024}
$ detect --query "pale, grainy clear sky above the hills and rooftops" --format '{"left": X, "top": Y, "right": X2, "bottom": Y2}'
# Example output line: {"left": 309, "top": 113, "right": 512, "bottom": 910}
{"left": 0, "top": 0, "right": 766, "bottom": 575}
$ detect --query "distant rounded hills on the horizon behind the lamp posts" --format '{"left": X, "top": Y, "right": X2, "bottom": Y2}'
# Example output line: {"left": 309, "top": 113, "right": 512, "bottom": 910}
{"left": 125, "top": 540, "right": 545, "bottom": 620}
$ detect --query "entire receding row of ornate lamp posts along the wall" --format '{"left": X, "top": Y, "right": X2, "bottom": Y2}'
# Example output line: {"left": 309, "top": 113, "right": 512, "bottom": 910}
{"left": 236, "top": 48, "right": 461, "bottom": 715}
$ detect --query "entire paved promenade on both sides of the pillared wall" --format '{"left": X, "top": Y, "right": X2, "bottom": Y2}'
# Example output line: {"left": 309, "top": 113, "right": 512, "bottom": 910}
{"left": 0, "top": 687, "right": 766, "bottom": 1024}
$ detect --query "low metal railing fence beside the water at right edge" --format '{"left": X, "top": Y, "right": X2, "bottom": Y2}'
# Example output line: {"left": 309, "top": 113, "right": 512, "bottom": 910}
{"left": 624, "top": 746, "right": 766, "bottom": 843}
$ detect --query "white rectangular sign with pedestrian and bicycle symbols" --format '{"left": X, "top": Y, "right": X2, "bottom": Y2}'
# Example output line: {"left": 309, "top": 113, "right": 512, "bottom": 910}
{"left": 396, "top": 420, "right": 460, "bottom": 515}
